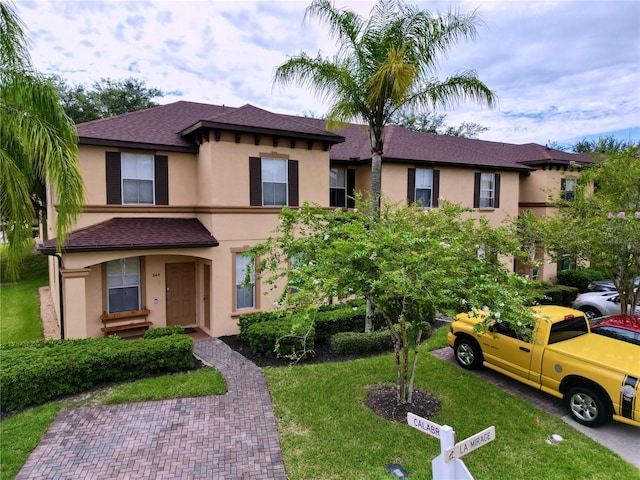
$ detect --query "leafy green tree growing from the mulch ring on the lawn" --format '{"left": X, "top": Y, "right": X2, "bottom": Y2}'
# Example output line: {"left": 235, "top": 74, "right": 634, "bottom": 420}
{"left": 248, "top": 201, "right": 531, "bottom": 403}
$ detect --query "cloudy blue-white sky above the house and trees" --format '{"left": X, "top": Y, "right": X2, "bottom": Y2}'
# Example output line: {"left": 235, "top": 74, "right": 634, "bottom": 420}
{"left": 15, "top": 0, "right": 640, "bottom": 146}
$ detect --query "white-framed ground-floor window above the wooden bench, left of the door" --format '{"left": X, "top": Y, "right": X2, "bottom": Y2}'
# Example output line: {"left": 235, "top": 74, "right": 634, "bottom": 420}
{"left": 107, "top": 257, "right": 140, "bottom": 313}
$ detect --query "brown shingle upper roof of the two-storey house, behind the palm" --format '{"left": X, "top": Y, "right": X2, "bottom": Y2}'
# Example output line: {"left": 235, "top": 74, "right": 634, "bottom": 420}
{"left": 77, "top": 101, "right": 591, "bottom": 172}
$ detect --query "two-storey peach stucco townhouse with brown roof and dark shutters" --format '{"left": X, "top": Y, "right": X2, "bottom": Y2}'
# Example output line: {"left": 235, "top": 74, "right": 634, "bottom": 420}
{"left": 40, "top": 102, "right": 588, "bottom": 338}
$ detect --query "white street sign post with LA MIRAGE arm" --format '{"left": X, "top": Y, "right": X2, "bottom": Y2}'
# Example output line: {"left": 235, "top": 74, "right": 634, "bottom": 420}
{"left": 407, "top": 413, "right": 496, "bottom": 480}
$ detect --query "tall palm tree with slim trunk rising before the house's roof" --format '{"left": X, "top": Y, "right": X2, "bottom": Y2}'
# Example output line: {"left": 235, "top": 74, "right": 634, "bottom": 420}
{"left": 275, "top": 0, "right": 497, "bottom": 331}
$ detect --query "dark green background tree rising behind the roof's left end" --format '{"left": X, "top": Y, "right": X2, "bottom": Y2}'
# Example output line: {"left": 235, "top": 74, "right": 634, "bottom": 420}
{"left": 52, "top": 76, "right": 164, "bottom": 124}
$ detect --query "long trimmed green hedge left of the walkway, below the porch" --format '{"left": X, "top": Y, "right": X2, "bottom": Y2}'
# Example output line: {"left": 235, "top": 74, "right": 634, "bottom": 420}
{"left": 0, "top": 335, "right": 194, "bottom": 412}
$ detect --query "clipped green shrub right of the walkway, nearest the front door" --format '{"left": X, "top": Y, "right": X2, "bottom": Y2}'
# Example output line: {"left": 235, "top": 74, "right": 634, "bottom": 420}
{"left": 246, "top": 315, "right": 315, "bottom": 358}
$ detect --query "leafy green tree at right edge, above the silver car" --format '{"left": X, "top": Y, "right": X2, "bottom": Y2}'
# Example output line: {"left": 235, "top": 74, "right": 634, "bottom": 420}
{"left": 541, "top": 145, "right": 640, "bottom": 313}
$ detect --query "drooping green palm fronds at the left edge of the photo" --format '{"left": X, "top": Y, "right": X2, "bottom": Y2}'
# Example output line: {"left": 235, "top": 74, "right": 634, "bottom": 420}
{"left": 0, "top": 2, "right": 84, "bottom": 279}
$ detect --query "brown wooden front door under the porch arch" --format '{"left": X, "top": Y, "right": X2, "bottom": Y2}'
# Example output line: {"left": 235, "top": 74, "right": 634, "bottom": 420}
{"left": 165, "top": 262, "right": 196, "bottom": 326}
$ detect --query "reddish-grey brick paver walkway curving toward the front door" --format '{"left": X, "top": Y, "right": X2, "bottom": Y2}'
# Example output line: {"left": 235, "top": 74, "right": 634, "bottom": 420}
{"left": 16, "top": 338, "right": 287, "bottom": 480}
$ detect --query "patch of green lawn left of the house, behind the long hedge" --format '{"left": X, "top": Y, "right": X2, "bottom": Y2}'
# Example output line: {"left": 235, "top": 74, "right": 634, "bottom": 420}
{"left": 0, "top": 245, "right": 49, "bottom": 343}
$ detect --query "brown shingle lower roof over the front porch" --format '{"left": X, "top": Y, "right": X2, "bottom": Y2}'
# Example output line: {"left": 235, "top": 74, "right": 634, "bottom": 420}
{"left": 39, "top": 218, "right": 218, "bottom": 255}
